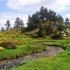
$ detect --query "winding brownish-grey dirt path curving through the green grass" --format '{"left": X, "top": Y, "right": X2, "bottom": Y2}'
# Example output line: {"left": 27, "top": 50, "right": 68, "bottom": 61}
{"left": 0, "top": 46, "right": 63, "bottom": 70}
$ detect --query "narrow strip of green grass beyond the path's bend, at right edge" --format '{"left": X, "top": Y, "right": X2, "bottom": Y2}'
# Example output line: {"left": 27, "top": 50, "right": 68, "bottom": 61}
{"left": 43, "top": 40, "right": 70, "bottom": 50}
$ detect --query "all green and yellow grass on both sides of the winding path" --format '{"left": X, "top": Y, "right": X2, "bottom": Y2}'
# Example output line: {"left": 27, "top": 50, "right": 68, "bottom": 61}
{"left": 0, "top": 29, "right": 70, "bottom": 70}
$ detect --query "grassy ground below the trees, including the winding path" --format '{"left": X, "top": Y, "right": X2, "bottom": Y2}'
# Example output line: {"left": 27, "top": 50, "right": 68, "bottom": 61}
{"left": 0, "top": 28, "right": 70, "bottom": 70}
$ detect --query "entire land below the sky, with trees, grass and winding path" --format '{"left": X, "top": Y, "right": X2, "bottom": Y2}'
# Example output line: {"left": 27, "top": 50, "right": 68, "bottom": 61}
{"left": 0, "top": 6, "right": 70, "bottom": 70}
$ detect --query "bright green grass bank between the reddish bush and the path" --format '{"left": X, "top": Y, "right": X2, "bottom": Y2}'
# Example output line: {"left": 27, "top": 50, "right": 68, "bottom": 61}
{"left": 0, "top": 44, "right": 45, "bottom": 60}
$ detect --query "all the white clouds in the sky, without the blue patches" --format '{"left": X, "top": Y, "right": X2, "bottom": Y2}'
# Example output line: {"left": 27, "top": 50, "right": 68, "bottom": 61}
{"left": 0, "top": 0, "right": 70, "bottom": 28}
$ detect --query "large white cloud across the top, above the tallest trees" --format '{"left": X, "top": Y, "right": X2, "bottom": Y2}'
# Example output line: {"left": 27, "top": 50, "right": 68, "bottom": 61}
{"left": 7, "top": 0, "right": 70, "bottom": 12}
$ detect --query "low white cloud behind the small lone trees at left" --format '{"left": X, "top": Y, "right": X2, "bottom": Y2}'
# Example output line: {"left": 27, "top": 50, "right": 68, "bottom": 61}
{"left": 0, "top": 12, "right": 28, "bottom": 28}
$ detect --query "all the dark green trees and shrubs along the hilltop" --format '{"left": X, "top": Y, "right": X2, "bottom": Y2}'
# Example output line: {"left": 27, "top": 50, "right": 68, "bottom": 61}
{"left": 2, "top": 6, "right": 70, "bottom": 39}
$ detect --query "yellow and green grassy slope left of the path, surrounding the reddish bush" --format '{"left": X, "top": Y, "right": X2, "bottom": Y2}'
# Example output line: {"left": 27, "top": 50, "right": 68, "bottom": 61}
{"left": 0, "top": 29, "right": 45, "bottom": 60}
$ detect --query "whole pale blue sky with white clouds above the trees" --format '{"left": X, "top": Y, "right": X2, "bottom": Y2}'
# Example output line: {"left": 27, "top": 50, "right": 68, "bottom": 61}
{"left": 0, "top": 0, "right": 70, "bottom": 29}
